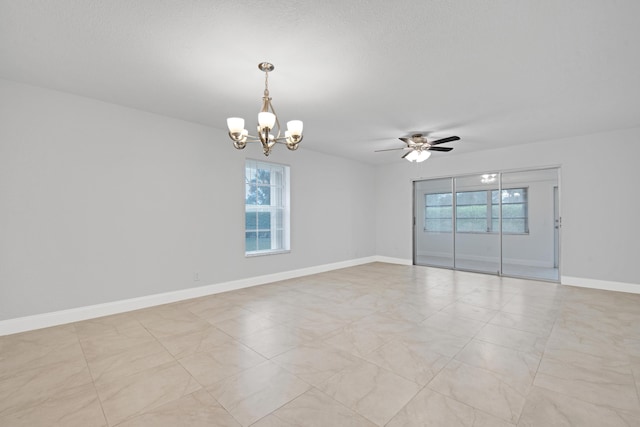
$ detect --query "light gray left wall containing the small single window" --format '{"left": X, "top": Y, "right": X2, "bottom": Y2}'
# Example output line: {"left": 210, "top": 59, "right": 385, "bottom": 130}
{"left": 0, "top": 80, "right": 375, "bottom": 320}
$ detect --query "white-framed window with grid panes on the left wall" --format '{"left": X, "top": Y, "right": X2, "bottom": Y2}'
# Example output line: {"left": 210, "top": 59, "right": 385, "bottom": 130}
{"left": 245, "top": 160, "right": 289, "bottom": 255}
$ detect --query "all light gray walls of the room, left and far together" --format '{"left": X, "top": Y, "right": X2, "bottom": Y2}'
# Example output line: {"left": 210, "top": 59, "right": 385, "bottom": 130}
{"left": 0, "top": 80, "right": 640, "bottom": 320}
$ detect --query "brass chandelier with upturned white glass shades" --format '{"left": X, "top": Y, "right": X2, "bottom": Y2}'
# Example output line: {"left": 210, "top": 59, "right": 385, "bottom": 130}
{"left": 227, "top": 62, "right": 302, "bottom": 156}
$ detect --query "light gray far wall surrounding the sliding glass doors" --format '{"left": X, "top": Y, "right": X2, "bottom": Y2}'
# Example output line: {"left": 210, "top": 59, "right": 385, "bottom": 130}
{"left": 376, "top": 128, "right": 640, "bottom": 286}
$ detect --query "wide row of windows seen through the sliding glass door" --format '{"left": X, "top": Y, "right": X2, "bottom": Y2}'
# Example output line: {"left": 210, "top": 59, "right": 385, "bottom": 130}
{"left": 424, "top": 188, "right": 529, "bottom": 234}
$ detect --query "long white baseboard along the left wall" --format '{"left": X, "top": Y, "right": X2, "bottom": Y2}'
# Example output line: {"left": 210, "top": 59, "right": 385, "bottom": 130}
{"left": 0, "top": 256, "right": 382, "bottom": 336}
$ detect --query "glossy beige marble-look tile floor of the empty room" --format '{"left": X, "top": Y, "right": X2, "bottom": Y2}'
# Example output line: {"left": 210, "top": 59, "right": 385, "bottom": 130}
{"left": 0, "top": 263, "right": 640, "bottom": 427}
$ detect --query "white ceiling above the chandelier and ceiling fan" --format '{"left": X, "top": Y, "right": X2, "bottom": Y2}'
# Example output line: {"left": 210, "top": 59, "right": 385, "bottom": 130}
{"left": 0, "top": 0, "right": 640, "bottom": 164}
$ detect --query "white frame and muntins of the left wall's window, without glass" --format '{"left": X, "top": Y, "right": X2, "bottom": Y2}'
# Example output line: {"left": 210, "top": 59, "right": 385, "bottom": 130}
{"left": 244, "top": 159, "right": 291, "bottom": 257}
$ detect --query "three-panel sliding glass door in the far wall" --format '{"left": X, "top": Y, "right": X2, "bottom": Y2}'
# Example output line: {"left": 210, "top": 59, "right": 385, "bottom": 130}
{"left": 414, "top": 168, "right": 560, "bottom": 281}
